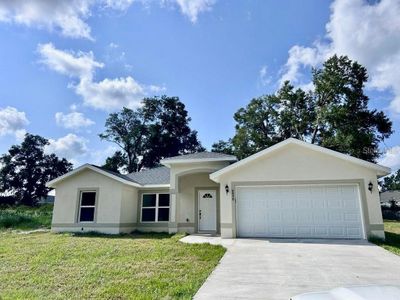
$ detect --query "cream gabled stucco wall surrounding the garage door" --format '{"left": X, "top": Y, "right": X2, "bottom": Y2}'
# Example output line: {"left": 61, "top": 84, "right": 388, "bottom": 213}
{"left": 219, "top": 145, "right": 384, "bottom": 238}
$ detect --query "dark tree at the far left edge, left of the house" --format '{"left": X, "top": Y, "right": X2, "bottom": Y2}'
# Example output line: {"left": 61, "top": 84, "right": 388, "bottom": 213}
{"left": 0, "top": 134, "right": 72, "bottom": 206}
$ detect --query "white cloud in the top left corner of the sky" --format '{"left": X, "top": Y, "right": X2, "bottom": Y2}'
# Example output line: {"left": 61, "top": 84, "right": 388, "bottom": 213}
{"left": 0, "top": 0, "right": 94, "bottom": 39}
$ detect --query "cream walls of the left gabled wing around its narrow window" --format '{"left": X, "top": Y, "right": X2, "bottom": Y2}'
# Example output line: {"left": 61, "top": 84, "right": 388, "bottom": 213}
{"left": 52, "top": 170, "right": 137, "bottom": 234}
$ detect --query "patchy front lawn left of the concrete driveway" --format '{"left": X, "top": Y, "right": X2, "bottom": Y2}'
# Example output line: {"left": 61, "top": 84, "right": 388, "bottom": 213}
{"left": 0, "top": 231, "right": 225, "bottom": 299}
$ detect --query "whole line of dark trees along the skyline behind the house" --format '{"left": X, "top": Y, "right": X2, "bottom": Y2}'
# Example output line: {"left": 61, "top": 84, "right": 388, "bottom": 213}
{"left": 0, "top": 55, "right": 400, "bottom": 205}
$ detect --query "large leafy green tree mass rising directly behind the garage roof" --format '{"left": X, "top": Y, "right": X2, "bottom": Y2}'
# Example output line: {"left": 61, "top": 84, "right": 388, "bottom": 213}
{"left": 217, "top": 55, "right": 393, "bottom": 161}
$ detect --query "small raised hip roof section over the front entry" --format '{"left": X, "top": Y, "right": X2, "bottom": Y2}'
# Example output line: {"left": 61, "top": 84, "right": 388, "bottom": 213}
{"left": 161, "top": 151, "right": 237, "bottom": 165}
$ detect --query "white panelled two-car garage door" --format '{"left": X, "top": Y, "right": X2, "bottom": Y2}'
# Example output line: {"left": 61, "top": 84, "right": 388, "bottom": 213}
{"left": 236, "top": 185, "right": 364, "bottom": 239}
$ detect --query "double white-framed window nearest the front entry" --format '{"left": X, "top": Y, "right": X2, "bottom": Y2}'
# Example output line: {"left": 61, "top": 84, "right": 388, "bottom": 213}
{"left": 142, "top": 194, "right": 170, "bottom": 222}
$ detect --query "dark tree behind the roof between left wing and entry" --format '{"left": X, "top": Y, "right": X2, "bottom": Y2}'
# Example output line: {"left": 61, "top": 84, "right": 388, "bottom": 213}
{"left": 99, "top": 96, "right": 204, "bottom": 172}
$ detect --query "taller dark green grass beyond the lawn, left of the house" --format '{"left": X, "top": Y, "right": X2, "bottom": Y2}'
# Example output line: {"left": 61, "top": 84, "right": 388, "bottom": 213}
{"left": 0, "top": 204, "right": 53, "bottom": 230}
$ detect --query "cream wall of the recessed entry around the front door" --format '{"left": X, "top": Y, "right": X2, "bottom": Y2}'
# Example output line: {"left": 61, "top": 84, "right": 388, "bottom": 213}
{"left": 177, "top": 172, "right": 219, "bottom": 233}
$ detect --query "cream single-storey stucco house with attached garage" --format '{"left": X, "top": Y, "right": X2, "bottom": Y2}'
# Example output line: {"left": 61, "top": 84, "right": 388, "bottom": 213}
{"left": 48, "top": 138, "right": 390, "bottom": 239}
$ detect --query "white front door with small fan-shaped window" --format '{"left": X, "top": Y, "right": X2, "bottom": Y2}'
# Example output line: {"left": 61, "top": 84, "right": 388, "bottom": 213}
{"left": 198, "top": 190, "right": 217, "bottom": 231}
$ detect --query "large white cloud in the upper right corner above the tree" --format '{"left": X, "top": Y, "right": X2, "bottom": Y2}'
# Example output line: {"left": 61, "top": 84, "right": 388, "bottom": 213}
{"left": 280, "top": 0, "right": 400, "bottom": 113}
